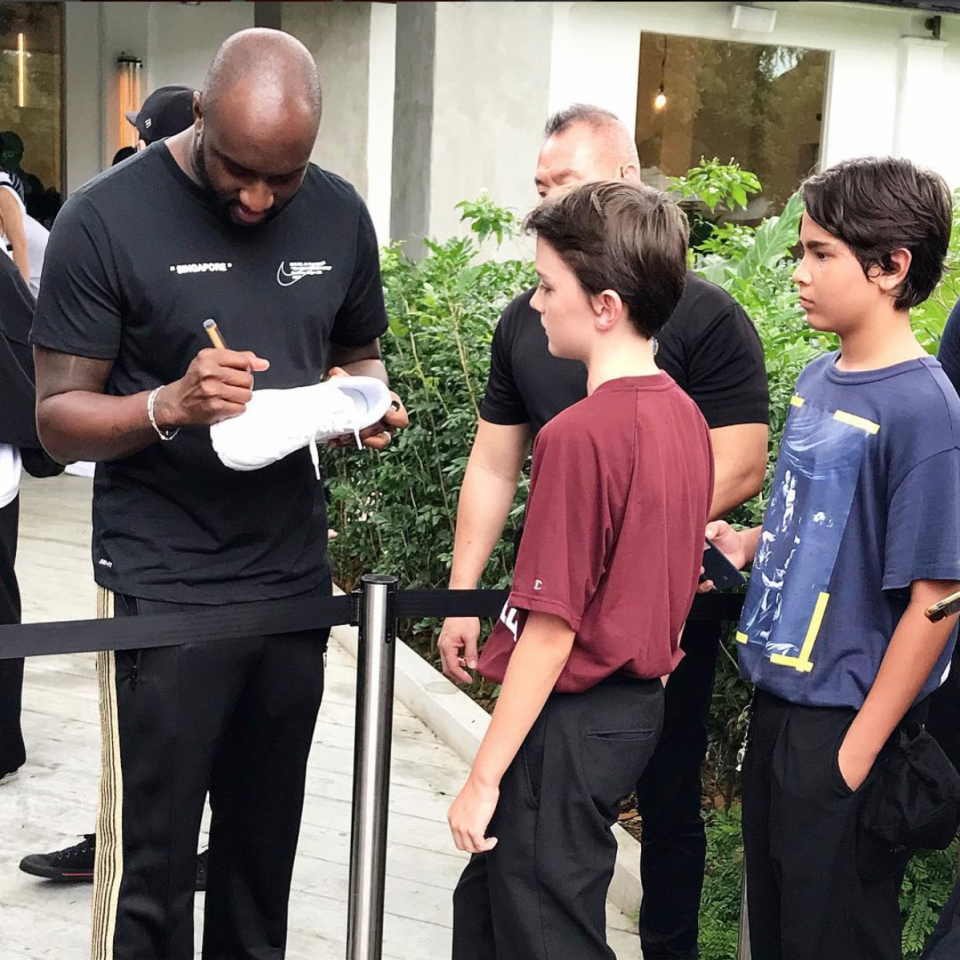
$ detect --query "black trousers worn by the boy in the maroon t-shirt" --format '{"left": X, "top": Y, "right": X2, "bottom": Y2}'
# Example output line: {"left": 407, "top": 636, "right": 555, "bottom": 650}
{"left": 453, "top": 680, "right": 663, "bottom": 960}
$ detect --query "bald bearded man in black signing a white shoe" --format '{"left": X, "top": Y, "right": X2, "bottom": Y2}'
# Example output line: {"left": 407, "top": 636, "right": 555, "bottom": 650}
{"left": 32, "top": 30, "right": 406, "bottom": 960}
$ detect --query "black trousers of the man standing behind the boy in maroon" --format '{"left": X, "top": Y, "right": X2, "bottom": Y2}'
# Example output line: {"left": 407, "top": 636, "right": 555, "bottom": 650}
{"left": 637, "top": 621, "right": 720, "bottom": 960}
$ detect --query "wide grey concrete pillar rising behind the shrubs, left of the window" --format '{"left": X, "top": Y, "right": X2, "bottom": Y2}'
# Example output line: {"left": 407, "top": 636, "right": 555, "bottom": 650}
{"left": 393, "top": 3, "right": 553, "bottom": 255}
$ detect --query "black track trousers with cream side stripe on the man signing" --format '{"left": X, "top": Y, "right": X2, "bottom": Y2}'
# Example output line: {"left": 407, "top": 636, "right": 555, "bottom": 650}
{"left": 92, "top": 583, "right": 330, "bottom": 960}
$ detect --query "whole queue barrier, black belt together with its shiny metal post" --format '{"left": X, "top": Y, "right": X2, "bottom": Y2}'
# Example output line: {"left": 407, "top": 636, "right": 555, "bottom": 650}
{"left": 0, "top": 574, "right": 743, "bottom": 960}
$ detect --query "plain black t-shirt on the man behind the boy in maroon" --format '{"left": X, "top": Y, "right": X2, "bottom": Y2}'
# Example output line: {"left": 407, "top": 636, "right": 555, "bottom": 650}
{"left": 480, "top": 273, "right": 770, "bottom": 435}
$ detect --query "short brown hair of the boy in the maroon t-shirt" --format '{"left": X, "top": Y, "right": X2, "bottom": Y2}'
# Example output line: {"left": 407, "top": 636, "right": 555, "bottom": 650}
{"left": 525, "top": 180, "right": 690, "bottom": 338}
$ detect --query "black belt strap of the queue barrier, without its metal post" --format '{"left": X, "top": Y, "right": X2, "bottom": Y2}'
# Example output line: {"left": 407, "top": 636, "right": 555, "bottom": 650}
{"left": 0, "top": 590, "right": 743, "bottom": 660}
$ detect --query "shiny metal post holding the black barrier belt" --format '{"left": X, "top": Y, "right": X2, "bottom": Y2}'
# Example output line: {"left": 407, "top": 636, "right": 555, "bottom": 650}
{"left": 347, "top": 574, "right": 397, "bottom": 960}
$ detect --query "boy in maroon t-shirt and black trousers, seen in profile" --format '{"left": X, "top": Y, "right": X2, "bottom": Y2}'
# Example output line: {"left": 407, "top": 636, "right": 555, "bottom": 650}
{"left": 449, "top": 181, "right": 713, "bottom": 960}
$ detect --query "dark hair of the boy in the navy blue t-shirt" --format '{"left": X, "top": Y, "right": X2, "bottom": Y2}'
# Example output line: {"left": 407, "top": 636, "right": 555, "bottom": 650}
{"left": 801, "top": 157, "right": 953, "bottom": 310}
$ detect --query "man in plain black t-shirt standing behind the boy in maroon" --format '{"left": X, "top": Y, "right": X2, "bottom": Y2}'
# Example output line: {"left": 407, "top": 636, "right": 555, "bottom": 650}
{"left": 440, "top": 104, "right": 768, "bottom": 960}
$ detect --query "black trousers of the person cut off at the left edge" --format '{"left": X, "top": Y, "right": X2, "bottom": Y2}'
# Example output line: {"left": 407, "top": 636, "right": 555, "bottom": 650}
{"left": 0, "top": 497, "right": 27, "bottom": 776}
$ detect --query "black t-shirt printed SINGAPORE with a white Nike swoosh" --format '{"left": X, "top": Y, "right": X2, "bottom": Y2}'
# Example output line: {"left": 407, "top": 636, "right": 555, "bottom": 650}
{"left": 32, "top": 142, "right": 387, "bottom": 604}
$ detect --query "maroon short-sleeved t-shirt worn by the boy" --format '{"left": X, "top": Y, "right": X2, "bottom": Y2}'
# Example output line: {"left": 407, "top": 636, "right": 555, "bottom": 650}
{"left": 479, "top": 373, "right": 713, "bottom": 693}
